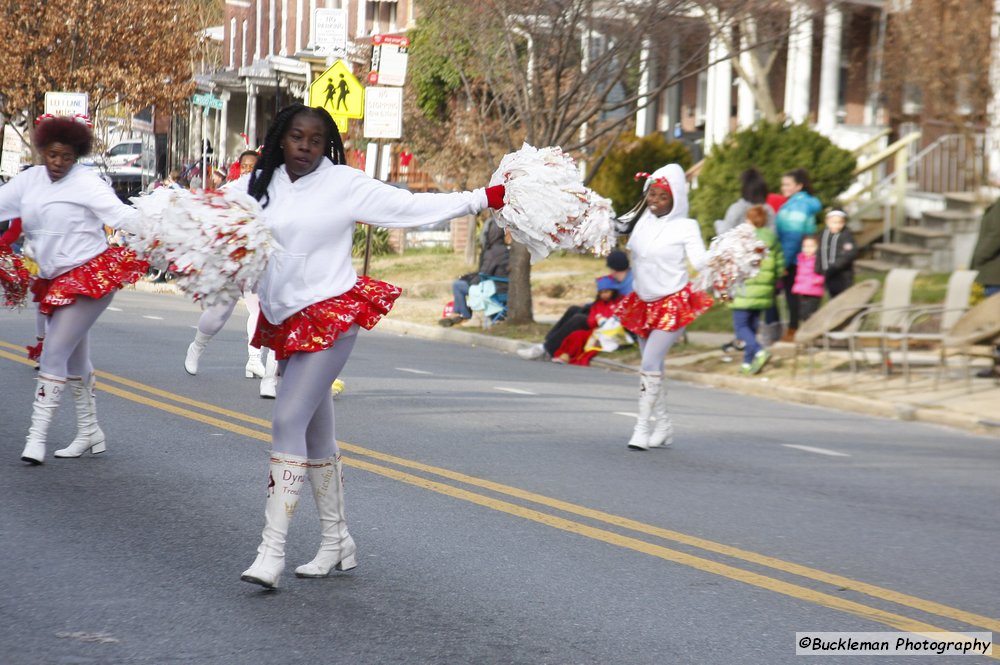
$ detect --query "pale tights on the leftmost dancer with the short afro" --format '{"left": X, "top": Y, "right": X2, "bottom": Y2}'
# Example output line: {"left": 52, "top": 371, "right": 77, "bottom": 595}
{"left": 40, "top": 293, "right": 114, "bottom": 379}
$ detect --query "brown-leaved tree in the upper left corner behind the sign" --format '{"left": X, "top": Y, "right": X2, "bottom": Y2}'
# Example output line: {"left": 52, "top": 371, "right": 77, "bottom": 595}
{"left": 0, "top": 0, "right": 203, "bottom": 132}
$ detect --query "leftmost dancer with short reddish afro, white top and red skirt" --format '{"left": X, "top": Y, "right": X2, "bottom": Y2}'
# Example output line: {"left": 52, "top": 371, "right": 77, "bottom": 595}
{"left": 0, "top": 116, "right": 148, "bottom": 464}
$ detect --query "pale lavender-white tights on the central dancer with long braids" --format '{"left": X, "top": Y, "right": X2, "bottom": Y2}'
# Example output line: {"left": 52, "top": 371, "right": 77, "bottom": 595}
{"left": 271, "top": 326, "right": 358, "bottom": 459}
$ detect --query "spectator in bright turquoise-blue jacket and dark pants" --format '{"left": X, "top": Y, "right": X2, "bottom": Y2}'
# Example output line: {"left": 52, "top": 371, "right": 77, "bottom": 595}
{"left": 775, "top": 169, "right": 823, "bottom": 341}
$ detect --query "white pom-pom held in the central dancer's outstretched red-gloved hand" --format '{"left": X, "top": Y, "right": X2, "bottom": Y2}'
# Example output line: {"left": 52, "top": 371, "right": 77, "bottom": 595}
{"left": 490, "top": 143, "right": 615, "bottom": 263}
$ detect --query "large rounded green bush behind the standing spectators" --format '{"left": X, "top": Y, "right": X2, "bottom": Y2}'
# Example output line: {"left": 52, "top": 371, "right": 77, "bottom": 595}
{"left": 691, "top": 122, "right": 856, "bottom": 236}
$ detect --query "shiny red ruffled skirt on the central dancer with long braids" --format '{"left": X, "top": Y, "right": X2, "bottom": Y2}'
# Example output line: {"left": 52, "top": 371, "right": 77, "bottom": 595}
{"left": 250, "top": 277, "right": 402, "bottom": 360}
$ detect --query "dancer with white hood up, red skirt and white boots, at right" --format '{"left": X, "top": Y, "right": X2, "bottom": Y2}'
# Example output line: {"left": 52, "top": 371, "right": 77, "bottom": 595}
{"left": 618, "top": 164, "right": 713, "bottom": 450}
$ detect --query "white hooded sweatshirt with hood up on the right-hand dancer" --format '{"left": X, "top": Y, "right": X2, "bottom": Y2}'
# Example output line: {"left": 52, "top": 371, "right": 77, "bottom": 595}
{"left": 627, "top": 164, "right": 707, "bottom": 302}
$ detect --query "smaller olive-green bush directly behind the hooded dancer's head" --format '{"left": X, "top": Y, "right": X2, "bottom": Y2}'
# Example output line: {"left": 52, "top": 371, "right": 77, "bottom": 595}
{"left": 590, "top": 133, "right": 692, "bottom": 215}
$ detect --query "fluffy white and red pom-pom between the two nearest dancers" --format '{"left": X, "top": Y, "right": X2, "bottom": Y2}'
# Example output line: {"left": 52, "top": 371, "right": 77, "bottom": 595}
{"left": 130, "top": 188, "right": 271, "bottom": 305}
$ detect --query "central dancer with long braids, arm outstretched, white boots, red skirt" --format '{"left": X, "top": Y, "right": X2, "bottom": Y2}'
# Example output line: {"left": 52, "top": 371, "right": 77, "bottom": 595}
{"left": 241, "top": 104, "right": 504, "bottom": 588}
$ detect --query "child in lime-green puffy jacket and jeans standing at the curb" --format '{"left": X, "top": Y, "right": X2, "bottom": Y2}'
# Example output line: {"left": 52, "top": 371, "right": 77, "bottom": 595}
{"left": 729, "top": 206, "right": 785, "bottom": 375}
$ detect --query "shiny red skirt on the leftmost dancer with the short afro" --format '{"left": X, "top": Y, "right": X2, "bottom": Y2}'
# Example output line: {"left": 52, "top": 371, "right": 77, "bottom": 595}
{"left": 31, "top": 247, "right": 149, "bottom": 315}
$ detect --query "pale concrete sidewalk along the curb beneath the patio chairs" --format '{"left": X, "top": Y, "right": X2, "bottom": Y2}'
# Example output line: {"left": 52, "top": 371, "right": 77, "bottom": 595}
{"left": 378, "top": 317, "right": 1000, "bottom": 439}
